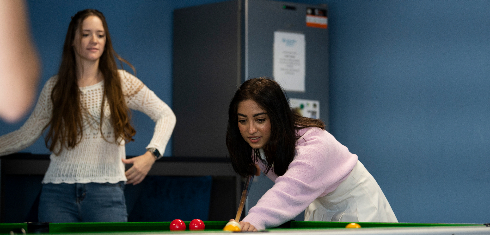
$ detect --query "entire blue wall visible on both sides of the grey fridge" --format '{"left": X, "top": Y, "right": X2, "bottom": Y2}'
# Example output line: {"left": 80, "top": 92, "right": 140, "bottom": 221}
{"left": 0, "top": 0, "right": 490, "bottom": 223}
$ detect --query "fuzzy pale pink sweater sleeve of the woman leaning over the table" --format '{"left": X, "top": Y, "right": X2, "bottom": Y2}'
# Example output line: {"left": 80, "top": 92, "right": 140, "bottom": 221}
{"left": 243, "top": 128, "right": 357, "bottom": 230}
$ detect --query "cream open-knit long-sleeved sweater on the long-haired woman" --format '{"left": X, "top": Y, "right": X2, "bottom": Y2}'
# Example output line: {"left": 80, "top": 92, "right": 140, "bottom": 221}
{"left": 0, "top": 70, "right": 176, "bottom": 183}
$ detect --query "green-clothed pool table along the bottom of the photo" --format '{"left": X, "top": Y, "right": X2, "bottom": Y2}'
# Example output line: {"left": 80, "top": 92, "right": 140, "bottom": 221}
{"left": 0, "top": 221, "right": 490, "bottom": 235}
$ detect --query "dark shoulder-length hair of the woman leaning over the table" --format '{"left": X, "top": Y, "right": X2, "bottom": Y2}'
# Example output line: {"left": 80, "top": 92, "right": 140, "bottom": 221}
{"left": 226, "top": 77, "right": 325, "bottom": 177}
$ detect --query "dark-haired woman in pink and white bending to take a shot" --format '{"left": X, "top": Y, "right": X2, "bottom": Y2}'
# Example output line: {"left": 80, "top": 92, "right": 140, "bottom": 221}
{"left": 226, "top": 78, "right": 397, "bottom": 231}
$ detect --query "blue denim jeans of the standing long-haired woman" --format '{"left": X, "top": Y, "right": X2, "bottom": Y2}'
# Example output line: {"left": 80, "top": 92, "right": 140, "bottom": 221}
{"left": 38, "top": 182, "right": 128, "bottom": 223}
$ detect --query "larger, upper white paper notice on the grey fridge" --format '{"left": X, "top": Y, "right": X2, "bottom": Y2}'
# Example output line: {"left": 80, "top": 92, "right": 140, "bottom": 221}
{"left": 274, "top": 32, "right": 305, "bottom": 92}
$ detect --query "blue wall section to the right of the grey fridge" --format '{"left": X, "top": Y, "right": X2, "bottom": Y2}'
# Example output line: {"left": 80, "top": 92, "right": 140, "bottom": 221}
{"left": 329, "top": 0, "right": 490, "bottom": 223}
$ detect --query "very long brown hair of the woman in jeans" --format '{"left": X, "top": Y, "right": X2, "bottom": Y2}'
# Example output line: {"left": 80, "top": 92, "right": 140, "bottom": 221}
{"left": 44, "top": 9, "right": 136, "bottom": 155}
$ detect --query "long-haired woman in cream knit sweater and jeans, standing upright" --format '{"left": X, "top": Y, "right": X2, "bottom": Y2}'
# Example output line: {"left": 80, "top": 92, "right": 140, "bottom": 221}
{"left": 0, "top": 9, "right": 176, "bottom": 222}
